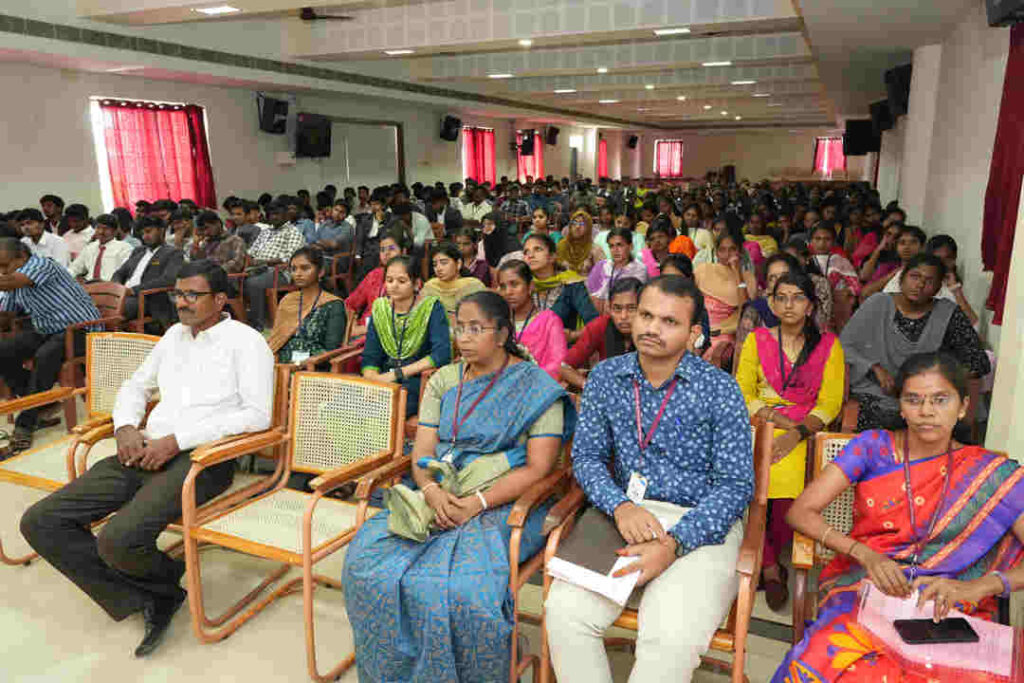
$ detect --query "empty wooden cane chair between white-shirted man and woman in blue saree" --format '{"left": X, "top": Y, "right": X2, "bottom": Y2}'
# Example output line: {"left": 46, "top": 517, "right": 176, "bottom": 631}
{"left": 182, "top": 372, "right": 406, "bottom": 681}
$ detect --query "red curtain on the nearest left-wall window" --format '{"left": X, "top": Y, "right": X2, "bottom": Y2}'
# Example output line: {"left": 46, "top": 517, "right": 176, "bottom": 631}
{"left": 99, "top": 100, "right": 217, "bottom": 208}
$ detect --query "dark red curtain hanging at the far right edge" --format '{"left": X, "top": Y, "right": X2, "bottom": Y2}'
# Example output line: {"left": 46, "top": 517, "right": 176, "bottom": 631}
{"left": 981, "top": 24, "right": 1024, "bottom": 325}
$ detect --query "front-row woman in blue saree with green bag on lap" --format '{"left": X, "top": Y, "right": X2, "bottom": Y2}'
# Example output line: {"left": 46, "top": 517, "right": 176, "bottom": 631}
{"left": 342, "top": 292, "right": 575, "bottom": 683}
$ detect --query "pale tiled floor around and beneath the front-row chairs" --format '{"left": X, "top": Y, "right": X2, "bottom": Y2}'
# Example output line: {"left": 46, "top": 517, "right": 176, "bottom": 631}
{"left": 0, "top": 419, "right": 788, "bottom": 683}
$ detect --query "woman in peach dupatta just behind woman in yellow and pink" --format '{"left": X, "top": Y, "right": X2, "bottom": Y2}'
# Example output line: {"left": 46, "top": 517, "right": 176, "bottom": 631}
{"left": 693, "top": 231, "right": 758, "bottom": 358}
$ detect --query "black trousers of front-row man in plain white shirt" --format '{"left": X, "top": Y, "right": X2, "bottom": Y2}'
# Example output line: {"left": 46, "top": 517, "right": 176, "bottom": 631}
{"left": 22, "top": 452, "right": 234, "bottom": 621}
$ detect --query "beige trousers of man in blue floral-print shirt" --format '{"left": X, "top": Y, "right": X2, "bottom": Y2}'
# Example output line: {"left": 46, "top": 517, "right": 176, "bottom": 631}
{"left": 545, "top": 503, "right": 743, "bottom": 683}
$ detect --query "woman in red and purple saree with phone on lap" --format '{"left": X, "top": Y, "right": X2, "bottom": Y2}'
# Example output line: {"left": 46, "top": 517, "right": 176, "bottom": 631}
{"left": 772, "top": 351, "right": 1024, "bottom": 683}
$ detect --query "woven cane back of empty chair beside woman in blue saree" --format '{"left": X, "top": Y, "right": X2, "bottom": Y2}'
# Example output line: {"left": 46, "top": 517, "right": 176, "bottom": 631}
{"left": 290, "top": 373, "right": 404, "bottom": 474}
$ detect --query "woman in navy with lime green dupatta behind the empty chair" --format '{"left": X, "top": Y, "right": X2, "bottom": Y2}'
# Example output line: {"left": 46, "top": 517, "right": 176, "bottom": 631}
{"left": 362, "top": 256, "right": 452, "bottom": 417}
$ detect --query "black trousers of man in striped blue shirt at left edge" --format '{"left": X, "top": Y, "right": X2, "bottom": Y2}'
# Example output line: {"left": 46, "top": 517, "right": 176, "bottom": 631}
{"left": 0, "top": 330, "right": 85, "bottom": 431}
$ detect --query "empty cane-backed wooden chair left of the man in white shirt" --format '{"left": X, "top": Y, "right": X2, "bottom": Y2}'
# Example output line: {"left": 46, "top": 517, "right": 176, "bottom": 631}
{"left": 0, "top": 332, "right": 160, "bottom": 564}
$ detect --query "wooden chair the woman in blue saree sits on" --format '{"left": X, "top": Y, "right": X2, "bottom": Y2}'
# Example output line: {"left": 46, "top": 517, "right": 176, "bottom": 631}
{"left": 355, "top": 423, "right": 577, "bottom": 683}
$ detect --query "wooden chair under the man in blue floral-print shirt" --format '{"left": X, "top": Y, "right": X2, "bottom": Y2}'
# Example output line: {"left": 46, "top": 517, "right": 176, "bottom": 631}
{"left": 540, "top": 422, "right": 774, "bottom": 683}
